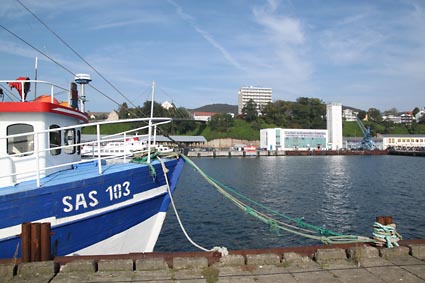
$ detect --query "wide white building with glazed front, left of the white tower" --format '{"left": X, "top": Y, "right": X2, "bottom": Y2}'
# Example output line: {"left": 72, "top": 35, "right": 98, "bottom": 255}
{"left": 260, "top": 128, "right": 328, "bottom": 150}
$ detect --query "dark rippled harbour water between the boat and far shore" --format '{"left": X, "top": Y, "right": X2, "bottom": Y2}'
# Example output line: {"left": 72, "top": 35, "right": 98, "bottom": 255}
{"left": 155, "top": 156, "right": 425, "bottom": 251}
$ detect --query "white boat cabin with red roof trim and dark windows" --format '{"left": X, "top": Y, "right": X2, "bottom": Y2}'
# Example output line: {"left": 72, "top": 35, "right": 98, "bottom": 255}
{"left": 0, "top": 78, "right": 88, "bottom": 187}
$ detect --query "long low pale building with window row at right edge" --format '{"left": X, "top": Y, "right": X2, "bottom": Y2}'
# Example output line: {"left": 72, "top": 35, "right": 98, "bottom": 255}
{"left": 382, "top": 134, "right": 425, "bottom": 151}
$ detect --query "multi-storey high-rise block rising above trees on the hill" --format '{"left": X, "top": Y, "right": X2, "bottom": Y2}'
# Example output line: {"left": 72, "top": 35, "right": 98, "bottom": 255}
{"left": 238, "top": 86, "right": 272, "bottom": 114}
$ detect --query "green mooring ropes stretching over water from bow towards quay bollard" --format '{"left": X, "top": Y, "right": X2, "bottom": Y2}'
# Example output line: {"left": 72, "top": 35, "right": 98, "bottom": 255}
{"left": 180, "top": 154, "right": 374, "bottom": 244}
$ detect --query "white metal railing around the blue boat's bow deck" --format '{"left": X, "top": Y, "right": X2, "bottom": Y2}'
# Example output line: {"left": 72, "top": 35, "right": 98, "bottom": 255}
{"left": 0, "top": 118, "right": 171, "bottom": 187}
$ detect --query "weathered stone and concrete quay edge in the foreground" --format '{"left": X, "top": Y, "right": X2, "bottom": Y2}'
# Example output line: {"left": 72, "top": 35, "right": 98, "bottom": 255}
{"left": 0, "top": 240, "right": 425, "bottom": 283}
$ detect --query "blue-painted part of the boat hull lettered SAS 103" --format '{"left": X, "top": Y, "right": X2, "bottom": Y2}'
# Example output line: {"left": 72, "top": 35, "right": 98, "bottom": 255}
{"left": 0, "top": 159, "right": 184, "bottom": 258}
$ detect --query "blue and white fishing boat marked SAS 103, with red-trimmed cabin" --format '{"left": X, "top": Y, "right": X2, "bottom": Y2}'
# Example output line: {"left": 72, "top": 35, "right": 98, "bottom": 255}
{"left": 0, "top": 74, "right": 184, "bottom": 258}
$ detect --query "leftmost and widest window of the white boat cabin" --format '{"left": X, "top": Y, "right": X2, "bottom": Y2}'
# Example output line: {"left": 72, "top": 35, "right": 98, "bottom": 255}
{"left": 6, "top": 124, "right": 34, "bottom": 156}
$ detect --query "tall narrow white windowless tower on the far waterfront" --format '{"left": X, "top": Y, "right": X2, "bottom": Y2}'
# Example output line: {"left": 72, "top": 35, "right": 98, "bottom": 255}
{"left": 326, "top": 103, "right": 343, "bottom": 150}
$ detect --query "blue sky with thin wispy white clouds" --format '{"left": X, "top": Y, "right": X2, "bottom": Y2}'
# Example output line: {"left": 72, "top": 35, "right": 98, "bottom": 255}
{"left": 0, "top": 0, "right": 425, "bottom": 111}
